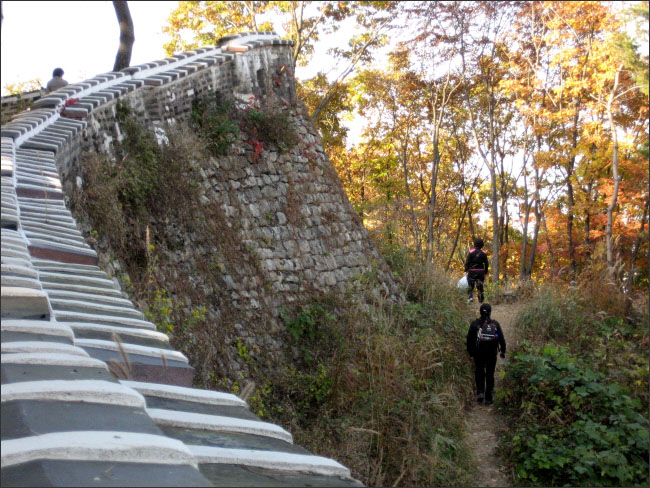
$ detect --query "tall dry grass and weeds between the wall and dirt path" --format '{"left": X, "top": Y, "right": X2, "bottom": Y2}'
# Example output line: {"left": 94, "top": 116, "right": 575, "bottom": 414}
{"left": 256, "top": 268, "right": 472, "bottom": 486}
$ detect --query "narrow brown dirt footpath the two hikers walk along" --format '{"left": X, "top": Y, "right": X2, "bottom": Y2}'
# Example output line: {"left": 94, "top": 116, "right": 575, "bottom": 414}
{"left": 466, "top": 303, "right": 523, "bottom": 486}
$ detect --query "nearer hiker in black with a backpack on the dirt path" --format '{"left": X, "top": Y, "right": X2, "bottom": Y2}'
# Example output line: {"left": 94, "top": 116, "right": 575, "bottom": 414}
{"left": 467, "top": 303, "right": 506, "bottom": 405}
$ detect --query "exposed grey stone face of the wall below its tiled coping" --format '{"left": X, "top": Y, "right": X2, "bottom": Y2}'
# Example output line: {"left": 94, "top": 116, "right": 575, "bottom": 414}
{"left": 69, "top": 33, "right": 398, "bottom": 298}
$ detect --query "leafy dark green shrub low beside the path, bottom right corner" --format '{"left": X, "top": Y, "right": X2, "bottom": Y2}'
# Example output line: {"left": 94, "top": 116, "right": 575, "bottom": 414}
{"left": 499, "top": 344, "right": 649, "bottom": 486}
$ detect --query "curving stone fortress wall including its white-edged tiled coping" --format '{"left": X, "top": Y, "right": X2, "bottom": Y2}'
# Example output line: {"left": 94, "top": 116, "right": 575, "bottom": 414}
{"left": 2, "top": 33, "right": 374, "bottom": 486}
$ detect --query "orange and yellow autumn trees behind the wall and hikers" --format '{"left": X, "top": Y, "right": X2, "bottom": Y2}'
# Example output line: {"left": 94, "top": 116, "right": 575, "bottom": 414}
{"left": 165, "top": 1, "right": 648, "bottom": 286}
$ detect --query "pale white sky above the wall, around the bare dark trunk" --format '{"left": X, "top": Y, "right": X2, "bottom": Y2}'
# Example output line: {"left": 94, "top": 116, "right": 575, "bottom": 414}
{"left": 0, "top": 1, "right": 178, "bottom": 95}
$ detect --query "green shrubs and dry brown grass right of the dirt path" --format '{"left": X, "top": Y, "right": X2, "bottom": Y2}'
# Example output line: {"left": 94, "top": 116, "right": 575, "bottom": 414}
{"left": 496, "top": 276, "right": 650, "bottom": 486}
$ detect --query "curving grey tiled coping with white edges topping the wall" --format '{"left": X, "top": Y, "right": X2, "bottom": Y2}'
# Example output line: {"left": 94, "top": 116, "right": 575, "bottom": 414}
{"left": 1, "top": 33, "right": 360, "bottom": 486}
